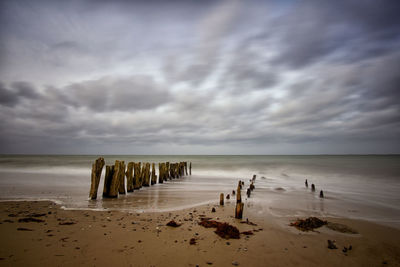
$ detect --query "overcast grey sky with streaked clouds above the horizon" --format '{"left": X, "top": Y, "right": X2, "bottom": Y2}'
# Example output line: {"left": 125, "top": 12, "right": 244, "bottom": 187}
{"left": 0, "top": 0, "right": 400, "bottom": 154}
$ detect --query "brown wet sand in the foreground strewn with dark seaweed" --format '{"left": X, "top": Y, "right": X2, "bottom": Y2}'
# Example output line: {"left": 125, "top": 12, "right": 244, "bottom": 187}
{"left": 0, "top": 201, "right": 400, "bottom": 266}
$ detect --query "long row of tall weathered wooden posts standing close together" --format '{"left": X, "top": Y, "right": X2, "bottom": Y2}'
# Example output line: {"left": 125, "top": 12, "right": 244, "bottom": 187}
{"left": 89, "top": 158, "right": 192, "bottom": 199}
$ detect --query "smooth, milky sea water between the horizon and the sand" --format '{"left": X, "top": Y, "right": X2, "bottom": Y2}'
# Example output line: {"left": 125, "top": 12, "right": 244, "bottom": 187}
{"left": 0, "top": 155, "right": 400, "bottom": 228}
